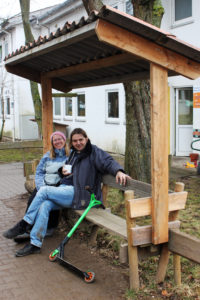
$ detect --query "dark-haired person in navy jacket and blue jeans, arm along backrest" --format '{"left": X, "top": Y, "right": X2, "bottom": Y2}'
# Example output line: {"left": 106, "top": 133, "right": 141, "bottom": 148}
{"left": 3, "top": 128, "right": 129, "bottom": 256}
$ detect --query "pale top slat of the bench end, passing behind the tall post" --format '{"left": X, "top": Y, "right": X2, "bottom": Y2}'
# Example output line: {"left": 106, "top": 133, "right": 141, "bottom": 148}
{"left": 128, "top": 192, "right": 188, "bottom": 218}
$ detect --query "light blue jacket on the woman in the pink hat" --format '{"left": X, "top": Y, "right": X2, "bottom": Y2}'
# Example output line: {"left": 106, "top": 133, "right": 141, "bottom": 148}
{"left": 35, "top": 148, "right": 67, "bottom": 191}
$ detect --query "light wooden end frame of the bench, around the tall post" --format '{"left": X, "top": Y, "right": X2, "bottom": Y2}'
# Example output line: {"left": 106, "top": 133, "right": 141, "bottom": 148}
{"left": 125, "top": 183, "right": 187, "bottom": 289}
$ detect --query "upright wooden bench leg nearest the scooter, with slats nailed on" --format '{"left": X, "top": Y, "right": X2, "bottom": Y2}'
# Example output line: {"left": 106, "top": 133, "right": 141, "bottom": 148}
{"left": 124, "top": 191, "right": 140, "bottom": 290}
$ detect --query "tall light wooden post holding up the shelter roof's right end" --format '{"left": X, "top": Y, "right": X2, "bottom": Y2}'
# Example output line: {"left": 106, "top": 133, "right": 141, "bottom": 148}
{"left": 150, "top": 63, "right": 168, "bottom": 244}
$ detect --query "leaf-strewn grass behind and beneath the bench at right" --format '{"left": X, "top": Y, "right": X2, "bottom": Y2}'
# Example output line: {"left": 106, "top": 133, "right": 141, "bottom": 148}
{"left": 99, "top": 176, "right": 200, "bottom": 300}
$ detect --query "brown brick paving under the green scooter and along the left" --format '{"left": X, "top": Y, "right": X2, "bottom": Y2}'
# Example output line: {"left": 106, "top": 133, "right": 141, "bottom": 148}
{"left": 0, "top": 163, "right": 128, "bottom": 300}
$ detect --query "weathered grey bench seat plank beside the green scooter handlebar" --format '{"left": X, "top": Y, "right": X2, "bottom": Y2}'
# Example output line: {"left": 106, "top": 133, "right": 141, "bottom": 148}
{"left": 76, "top": 208, "right": 127, "bottom": 239}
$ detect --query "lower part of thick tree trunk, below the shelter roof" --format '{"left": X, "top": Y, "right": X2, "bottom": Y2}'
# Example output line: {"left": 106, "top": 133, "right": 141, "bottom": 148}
{"left": 124, "top": 80, "right": 151, "bottom": 182}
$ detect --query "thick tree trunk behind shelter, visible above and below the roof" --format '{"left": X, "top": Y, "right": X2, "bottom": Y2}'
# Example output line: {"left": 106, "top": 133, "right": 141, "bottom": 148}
{"left": 124, "top": 0, "right": 164, "bottom": 182}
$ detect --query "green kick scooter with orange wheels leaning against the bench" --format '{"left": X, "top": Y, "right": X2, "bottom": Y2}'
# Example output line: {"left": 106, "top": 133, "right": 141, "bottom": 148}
{"left": 49, "top": 186, "right": 105, "bottom": 283}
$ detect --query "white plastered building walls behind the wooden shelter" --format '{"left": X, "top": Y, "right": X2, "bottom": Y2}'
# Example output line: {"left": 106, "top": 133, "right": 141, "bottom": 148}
{"left": 0, "top": 0, "right": 200, "bottom": 154}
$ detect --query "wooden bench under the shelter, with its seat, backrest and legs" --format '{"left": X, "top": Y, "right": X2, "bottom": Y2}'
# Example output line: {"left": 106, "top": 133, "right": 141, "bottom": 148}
{"left": 23, "top": 162, "right": 191, "bottom": 289}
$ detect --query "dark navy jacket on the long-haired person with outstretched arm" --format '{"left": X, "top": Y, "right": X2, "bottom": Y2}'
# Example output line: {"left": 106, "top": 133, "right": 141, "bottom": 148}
{"left": 61, "top": 140, "right": 124, "bottom": 209}
